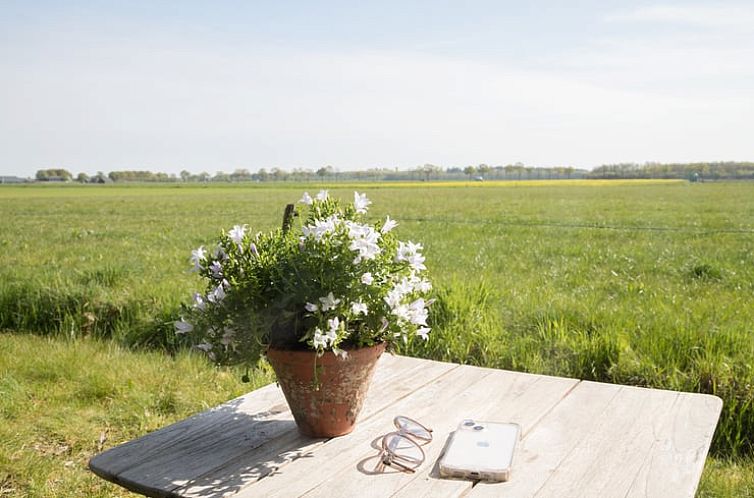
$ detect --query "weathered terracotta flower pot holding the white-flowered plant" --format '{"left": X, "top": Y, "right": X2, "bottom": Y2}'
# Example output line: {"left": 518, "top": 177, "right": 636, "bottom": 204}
{"left": 267, "top": 344, "right": 385, "bottom": 437}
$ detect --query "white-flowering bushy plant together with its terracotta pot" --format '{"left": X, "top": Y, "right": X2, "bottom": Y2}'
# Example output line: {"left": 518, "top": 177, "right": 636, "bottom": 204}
{"left": 175, "top": 190, "right": 431, "bottom": 436}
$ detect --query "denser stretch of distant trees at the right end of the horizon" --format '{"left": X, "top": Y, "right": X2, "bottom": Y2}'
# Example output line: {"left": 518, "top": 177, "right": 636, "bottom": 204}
{"left": 587, "top": 161, "right": 754, "bottom": 181}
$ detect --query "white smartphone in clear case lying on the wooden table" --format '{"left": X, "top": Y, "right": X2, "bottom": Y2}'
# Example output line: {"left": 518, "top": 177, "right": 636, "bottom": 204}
{"left": 439, "top": 420, "right": 521, "bottom": 482}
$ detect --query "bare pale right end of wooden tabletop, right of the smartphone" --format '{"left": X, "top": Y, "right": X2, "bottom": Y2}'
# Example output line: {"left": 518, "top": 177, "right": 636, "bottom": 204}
{"left": 469, "top": 382, "right": 721, "bottom": 498}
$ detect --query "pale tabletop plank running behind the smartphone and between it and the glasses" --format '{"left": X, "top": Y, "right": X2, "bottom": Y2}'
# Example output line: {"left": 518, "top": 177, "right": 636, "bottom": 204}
{"left": 388, "top": 374, "right": 578, "bottom": 498}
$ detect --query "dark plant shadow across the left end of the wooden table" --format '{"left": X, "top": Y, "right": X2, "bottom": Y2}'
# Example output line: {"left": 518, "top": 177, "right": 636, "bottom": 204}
{"left": 89, "top": 390, "right": 324, "bottom": 496}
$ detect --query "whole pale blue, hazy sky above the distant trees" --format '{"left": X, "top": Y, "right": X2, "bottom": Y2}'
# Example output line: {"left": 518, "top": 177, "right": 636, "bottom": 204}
{"left": 0, "top": 0, "right": 754, "bottom": 176}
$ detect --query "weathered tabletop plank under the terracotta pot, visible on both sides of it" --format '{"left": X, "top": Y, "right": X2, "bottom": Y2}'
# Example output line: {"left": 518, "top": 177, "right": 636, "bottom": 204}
{"left": 173, "top": 357, "right": 458, "bottom": 496}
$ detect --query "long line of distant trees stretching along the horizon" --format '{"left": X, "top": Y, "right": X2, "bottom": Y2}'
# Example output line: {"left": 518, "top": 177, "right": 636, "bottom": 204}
{"left": 36, "top": 162, "right": 754, "bottom": 183}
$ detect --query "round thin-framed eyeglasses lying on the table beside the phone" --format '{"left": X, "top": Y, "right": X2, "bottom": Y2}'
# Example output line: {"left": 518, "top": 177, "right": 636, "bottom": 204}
{"left": 375, "top": 415, "right": 432, "bottom": 473}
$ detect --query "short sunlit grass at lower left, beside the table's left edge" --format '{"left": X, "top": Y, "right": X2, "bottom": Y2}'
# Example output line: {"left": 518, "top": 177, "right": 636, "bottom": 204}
{"left": 0, "top": 333, "right": 272, "bottom": 497}
